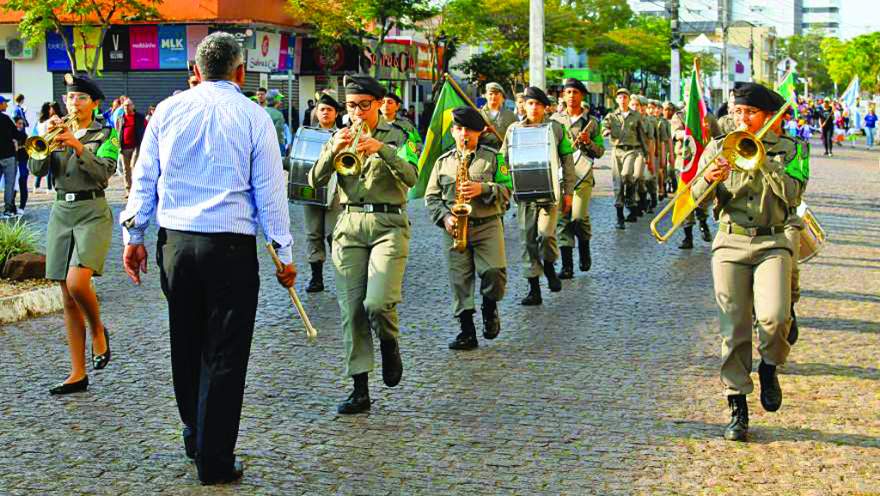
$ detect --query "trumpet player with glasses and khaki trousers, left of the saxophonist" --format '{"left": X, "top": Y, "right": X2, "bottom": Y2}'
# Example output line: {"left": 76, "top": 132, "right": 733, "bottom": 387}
{"left": 309, "top": 75, "right": 418, "bottom": 414}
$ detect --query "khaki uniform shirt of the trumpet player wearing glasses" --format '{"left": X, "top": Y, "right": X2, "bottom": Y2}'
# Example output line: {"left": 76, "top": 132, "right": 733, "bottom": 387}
{"left": 309, "top": 120, "right": 418, "bottom": 206}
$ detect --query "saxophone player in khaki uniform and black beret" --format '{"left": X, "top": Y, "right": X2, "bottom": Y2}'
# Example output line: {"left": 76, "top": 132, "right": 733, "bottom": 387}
{"left": 425, "top": 106, "right": 512, "bottom": 350}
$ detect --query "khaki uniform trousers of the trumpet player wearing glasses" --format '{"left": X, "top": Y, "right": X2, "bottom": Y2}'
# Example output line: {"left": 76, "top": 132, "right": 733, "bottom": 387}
{"left": 332, "top": 212, "right": 410, "bottom": 376}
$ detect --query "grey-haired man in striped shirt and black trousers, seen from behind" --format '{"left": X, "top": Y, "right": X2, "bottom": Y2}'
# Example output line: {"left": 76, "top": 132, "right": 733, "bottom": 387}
{"left": 120, "top": 32, "right": 296, "bottom": 484}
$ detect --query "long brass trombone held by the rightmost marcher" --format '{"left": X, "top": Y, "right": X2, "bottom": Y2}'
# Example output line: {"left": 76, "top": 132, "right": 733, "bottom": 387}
{"left": 651, "top": 102, "right": 791, "bottom": 243}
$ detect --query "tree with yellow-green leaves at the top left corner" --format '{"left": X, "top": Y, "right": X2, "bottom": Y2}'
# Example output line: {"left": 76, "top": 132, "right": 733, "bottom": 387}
{"left": 0, "top": 0, "right": 162, "bottom": 77}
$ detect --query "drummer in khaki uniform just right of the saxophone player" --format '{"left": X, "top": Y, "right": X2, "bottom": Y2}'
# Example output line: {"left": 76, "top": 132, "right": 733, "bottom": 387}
{"left": 501, "top": 86, "right": 576, "bottom": 305}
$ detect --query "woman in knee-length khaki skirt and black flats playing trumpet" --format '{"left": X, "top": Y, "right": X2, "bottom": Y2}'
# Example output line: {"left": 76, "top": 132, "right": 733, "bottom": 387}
{"left": 28, "top": 74, "right": 119, "bottom": 394}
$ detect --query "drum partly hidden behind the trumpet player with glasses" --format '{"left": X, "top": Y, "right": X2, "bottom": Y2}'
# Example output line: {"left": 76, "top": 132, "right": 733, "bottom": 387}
{"left": 287, "top": 127, "right": 336, "bottom": 207}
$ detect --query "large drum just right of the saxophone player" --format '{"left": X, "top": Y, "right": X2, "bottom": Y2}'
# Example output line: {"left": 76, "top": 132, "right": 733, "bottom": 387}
{"left": 508, "top": 123, "right": 562, "bottom": 204}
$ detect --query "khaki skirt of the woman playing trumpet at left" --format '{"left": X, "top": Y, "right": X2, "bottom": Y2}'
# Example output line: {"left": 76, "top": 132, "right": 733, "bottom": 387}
{"left": 46, "top": 197, "right": 113, "bottom": 281}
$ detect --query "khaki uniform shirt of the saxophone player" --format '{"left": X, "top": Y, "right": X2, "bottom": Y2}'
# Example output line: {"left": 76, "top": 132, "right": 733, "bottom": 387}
{"left": 425, "top": 146, "right": 510, "bottom": 227}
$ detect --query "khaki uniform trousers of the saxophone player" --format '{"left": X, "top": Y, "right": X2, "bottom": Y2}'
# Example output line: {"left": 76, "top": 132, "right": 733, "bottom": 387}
{"left": 443, "top": 217, "right": 507, "bottom": 317}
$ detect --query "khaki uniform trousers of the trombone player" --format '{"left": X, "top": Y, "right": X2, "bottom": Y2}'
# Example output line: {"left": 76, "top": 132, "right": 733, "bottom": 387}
{"left": 712, "top": 232, "right": 792, "bottom": 395}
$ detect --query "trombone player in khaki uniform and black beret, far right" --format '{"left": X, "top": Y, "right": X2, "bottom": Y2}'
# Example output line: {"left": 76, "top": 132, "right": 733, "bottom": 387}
{"left": 691, "top": 83, "right": 803, "bottom": 441}
